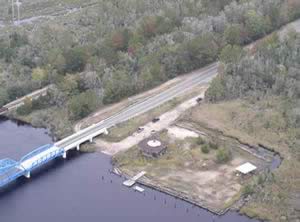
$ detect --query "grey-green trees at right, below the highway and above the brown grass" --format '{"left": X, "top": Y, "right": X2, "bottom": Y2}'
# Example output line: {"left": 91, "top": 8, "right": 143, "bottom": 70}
{"left": 206, "top": 31, "right": 300, "bottom": 102}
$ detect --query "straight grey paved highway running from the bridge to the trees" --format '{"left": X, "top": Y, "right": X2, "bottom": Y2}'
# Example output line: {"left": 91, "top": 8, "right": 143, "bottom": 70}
{"left": 55, "top": 63, "right": 218, "bottom": 148}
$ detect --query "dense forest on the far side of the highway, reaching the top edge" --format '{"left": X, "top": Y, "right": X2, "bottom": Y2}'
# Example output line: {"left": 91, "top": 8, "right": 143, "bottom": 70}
{"left": 0, "top": 0, "right": 300, "bottom": 136}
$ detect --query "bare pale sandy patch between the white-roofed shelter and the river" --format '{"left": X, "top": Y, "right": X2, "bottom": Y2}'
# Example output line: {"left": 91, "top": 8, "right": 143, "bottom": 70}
{"left": 156, "top": 158, "right": 246, "bottom": 209}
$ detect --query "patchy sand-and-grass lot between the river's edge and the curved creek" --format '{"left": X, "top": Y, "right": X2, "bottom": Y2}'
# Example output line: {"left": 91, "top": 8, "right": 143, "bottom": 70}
{"left": 114, "top": 126, "right": 265, "bottom": 213}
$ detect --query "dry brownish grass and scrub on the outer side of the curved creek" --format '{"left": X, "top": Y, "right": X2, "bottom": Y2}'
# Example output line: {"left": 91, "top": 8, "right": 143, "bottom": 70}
{"left": 183, "top": 97, "right": 300, "bottom": 221}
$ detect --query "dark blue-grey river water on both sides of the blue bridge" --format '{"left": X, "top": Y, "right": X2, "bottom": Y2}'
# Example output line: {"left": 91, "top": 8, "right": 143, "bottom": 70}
{"left": 0, "top": 119, "right": 256, "bottom": 222}
